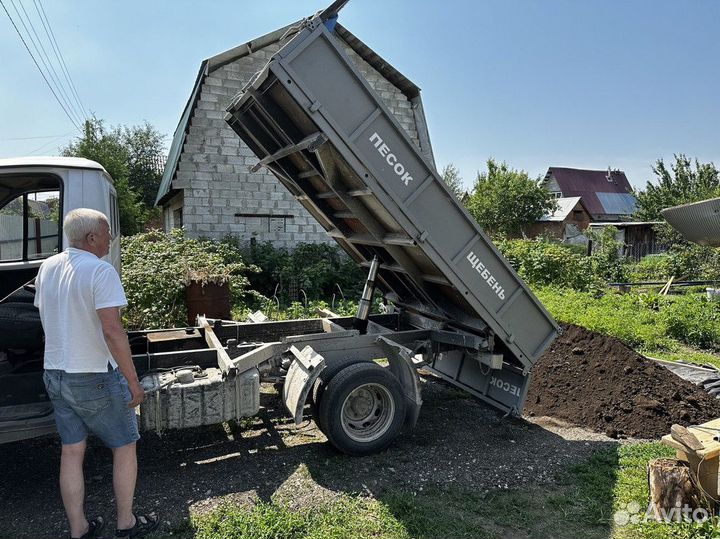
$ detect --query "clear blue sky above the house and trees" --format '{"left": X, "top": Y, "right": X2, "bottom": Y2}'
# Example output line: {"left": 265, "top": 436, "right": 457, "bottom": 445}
{"left": 0, "top": 0, "right": 720, "bottom": 192}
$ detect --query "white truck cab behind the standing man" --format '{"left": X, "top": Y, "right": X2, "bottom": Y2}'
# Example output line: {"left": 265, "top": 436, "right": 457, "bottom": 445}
{"left": 0, "top": 157, "right": 120, "bottom": 443}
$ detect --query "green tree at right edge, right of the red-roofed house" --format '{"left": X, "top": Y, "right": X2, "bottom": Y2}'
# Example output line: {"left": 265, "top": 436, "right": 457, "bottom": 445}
{"left": 634, "top": 154, "right": 720, "bottom": 221}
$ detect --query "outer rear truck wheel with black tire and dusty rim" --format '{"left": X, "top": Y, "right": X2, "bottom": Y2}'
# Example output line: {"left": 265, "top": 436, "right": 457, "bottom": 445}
{"left": 319, "top": 362, "right": 406, "bottom": 455}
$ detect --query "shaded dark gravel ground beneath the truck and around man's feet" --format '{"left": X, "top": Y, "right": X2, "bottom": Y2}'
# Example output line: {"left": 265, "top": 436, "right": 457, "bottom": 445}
{"left": 0, "top": 377, "right": 616, "bottom": 539}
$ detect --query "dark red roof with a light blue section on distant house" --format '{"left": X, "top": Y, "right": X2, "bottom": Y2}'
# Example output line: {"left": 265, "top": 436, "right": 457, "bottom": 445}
{"left": 545, "top": 167, "right": 636, "bottom": 219}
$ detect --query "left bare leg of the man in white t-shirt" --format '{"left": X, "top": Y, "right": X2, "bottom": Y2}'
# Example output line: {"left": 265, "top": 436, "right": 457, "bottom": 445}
{"left": 60, "top": 440, "right": 90, "bottom": 537}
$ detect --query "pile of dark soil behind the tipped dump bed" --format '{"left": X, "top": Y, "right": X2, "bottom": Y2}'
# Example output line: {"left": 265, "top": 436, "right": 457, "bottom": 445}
{"left": 525, "top": 325, "right": 720, "bottom": 438}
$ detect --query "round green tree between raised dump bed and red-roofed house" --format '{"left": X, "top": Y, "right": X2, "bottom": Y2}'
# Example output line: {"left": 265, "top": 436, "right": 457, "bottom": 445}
{"left": 467, "top": 159, "right": 557, "bottom": 235}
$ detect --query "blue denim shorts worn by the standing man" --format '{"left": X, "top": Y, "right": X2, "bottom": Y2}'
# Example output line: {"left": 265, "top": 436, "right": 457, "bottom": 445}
{"left": 43, "top": 369, "right": 140, "bottom": 449}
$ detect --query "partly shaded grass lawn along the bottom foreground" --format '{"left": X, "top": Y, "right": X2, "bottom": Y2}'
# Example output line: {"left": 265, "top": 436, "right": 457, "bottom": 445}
{"left": 184, "top": 443, "right": 720, "bottom": 539}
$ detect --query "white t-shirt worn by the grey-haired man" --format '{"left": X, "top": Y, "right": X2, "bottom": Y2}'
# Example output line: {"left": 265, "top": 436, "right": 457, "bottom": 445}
{"left": 35, "top": 247, "right": 127, "bottom": 372}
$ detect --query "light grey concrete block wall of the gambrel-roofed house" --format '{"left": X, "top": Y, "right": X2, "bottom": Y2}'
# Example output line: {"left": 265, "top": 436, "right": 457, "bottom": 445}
{"left": 173, "top": 38, "right": 419, "bottom": 248}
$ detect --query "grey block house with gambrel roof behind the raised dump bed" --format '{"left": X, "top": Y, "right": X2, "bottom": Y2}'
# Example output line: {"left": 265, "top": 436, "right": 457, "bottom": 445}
{"left": 156, "top": 19, "right": 434, "bottom": 248}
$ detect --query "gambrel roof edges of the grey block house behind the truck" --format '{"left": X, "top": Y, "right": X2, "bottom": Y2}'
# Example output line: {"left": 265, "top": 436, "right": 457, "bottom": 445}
{"left": 155, "top": 21, "right": 420, "bottom": 206}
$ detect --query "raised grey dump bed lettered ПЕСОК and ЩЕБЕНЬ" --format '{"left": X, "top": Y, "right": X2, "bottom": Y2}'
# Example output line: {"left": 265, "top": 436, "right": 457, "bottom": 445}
{"left": 226, "top": 13, "right": 559, "bottom": 392}
